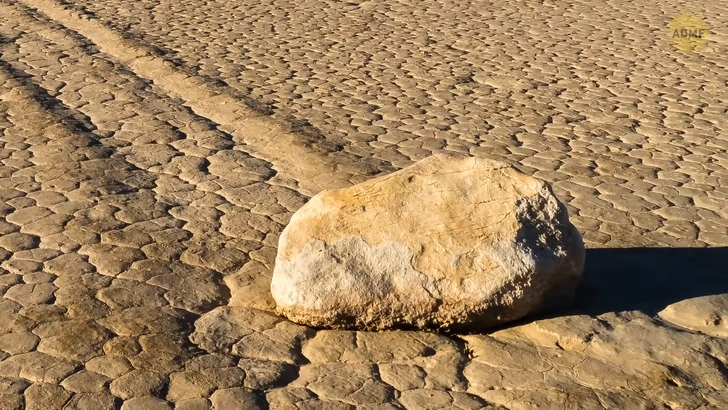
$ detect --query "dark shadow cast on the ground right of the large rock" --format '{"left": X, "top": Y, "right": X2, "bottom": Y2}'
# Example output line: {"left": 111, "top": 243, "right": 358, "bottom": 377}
{"left": 572, "top": 247, "right": 728, "bottom": 316}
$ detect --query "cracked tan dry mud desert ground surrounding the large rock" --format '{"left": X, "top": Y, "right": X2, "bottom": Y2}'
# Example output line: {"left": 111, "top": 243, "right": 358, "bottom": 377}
{"left": 0, "top": 0, "right": 728, "bottom": 410}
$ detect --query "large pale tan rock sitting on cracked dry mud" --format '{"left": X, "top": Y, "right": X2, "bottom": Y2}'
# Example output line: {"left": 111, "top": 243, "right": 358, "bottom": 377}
{"left": 271, "top": 155, "right": 584, "bottom": 330}
